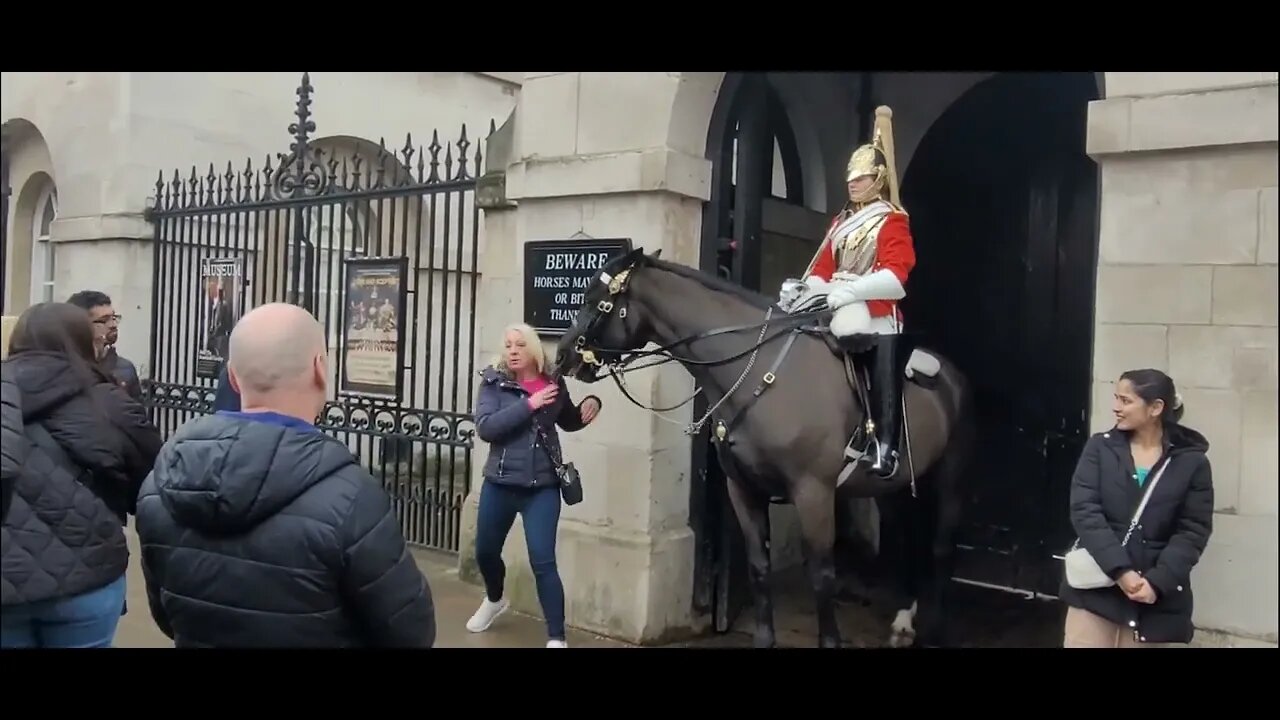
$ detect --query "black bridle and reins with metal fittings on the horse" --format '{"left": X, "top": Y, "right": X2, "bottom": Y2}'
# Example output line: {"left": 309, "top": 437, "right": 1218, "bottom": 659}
{"left": 573, "top": 257, "right": 822, "bottom": 441}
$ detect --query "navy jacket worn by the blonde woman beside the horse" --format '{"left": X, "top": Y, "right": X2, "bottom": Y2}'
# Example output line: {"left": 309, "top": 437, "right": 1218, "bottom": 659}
{"left": 475, "top": 366, "right": 603, "bottom": 487}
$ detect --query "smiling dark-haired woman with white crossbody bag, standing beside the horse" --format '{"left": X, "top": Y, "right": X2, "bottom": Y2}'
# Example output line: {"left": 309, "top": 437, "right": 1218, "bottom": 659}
{"left": 1060, "top": 369, "right": 1213, "bottom": 647}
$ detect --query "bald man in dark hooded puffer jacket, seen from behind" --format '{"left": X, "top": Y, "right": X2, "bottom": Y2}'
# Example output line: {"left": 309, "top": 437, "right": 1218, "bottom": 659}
{"left": 137, "top": 304, "right": 435, "bottom": 647}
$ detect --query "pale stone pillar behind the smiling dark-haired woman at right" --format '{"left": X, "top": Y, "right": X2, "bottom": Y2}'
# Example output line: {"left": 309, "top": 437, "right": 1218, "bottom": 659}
{"left": 1088, "top": 73, "right": 1277, "bottom": 643}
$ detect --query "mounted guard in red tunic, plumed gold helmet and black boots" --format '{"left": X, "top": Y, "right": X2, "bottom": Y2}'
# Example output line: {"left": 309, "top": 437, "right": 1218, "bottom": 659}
{"left": 781, "top": 106, "right": 915, "bottom": 478}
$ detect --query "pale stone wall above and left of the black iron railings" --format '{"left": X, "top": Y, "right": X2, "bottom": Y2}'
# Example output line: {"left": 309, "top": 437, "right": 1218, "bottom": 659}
{"left": 0, "top": 72, "right": 520, "bottom": 377}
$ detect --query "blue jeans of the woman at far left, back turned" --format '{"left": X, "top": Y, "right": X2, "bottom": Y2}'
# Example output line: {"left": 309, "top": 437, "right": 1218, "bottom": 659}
{"left": 0, "top": 575, "right": 124, "bottom": 648}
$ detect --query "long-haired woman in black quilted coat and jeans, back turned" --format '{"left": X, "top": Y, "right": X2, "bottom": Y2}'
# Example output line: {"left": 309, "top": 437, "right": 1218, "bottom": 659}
{"left": 0, "top": 302, "right": 161, "bottom": 648}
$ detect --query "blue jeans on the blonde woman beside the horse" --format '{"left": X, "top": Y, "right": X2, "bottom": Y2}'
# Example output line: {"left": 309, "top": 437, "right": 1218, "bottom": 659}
{"left": 476, "top": 482, "right": 564, "bottom": 641}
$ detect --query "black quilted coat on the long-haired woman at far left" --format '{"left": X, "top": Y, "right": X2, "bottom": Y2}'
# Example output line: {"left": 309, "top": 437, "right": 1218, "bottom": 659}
{"left": 0, "top": 352, "right": 160, "bottom": 606}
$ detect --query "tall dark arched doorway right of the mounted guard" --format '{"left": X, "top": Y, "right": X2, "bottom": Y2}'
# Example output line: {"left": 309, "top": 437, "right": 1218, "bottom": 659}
{"left": 902, "top": 73, "right": 1098, "bottom": 594}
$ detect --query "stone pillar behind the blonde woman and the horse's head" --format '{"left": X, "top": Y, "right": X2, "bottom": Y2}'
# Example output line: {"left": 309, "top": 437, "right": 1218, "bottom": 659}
{"left": 460, "top": 73, "right": 719, "bottom": 643}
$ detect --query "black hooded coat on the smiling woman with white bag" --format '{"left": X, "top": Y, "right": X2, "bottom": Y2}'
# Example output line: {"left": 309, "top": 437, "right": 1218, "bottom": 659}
{"left": 1059, "top": 425, "right": 1213, "bottom": 643}
